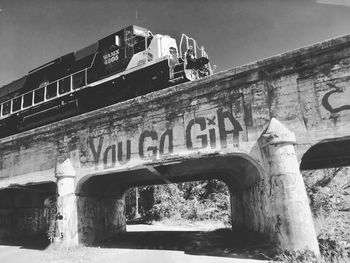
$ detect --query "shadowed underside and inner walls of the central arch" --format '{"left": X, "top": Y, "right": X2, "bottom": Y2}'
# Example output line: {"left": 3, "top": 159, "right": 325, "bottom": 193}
{"left": 76, "top": 154, "right": 263, "bottom": 244}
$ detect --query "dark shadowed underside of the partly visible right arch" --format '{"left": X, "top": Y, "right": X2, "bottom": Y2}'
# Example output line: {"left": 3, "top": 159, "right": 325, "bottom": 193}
{"left": 300, "top": 137, "right": 350, "bottom": 170}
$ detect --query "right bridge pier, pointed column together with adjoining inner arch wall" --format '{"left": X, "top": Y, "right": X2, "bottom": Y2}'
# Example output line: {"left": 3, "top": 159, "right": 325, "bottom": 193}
{"left": 229, "top": 118, "right": 319, "bottom": 253}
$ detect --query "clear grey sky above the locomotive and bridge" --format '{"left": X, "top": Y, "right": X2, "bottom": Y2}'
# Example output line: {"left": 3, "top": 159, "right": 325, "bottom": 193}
{"left": 0, "top": 0, "right": 350, "bottom": 86}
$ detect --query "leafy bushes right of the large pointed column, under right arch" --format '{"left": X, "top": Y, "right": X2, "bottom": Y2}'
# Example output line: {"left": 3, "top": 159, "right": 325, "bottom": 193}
{"left": 303, "top": 167, "right": 350, "bottom": 263}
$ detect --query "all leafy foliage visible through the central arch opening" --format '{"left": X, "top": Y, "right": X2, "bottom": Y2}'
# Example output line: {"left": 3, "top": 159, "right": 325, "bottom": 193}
{"left": 126, "top": 180, "right": 230, "bottom": 224}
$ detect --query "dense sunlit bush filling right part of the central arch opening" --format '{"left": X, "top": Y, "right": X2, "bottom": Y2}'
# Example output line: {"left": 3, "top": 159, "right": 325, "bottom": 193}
{"left": 152, "top": 183, "right": 230, "bottom": 224}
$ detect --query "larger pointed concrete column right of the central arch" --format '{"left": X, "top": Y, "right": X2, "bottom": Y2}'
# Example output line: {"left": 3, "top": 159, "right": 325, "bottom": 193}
{"left": 259, "top": 118, "right": 319, "bottom": 254}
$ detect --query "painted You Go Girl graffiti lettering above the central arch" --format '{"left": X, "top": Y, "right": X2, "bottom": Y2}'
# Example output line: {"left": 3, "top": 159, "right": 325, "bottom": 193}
{"left": 87, "top": 109, "right": 242, "bottom": 170}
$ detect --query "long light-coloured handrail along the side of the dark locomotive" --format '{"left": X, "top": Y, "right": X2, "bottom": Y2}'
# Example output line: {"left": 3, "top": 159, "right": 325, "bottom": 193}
{"left": 0, "top": 52, "right": 97, "bottom": 119}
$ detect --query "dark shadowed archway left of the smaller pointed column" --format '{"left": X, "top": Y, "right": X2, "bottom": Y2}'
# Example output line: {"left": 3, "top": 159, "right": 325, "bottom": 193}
{"left": 0, "top": 181, "right": 57, "bottom": 249}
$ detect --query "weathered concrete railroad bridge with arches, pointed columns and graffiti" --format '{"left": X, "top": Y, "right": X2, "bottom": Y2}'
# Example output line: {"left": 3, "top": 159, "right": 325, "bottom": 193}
{"left": 0, "top": 32, "right": 350, "bottom": 253}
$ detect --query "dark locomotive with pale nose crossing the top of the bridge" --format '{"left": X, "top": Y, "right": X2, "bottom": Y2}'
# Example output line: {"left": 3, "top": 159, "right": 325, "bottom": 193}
{"left": 0, "top": 25, "right": 212, "bottom": 138}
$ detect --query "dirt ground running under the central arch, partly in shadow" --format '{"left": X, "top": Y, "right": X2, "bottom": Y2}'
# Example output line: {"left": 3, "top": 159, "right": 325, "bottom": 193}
{"left": 0, "top": 224, "right": 268, "bottom": 263}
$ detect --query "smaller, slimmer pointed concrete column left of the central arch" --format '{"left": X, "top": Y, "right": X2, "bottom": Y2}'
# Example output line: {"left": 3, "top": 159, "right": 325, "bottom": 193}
{"left": 54, "top": 159, "right": 78, "bottom": 247}
